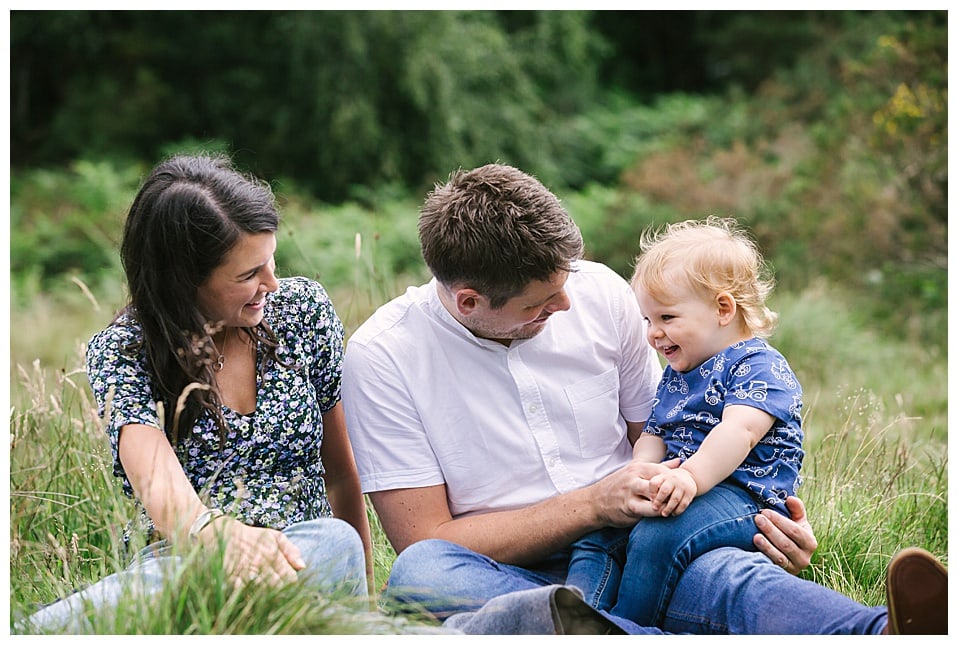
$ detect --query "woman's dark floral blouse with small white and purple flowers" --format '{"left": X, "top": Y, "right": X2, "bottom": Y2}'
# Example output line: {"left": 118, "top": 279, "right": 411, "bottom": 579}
{"left": 87, "top": 278, "right": 344, "bottom": 529}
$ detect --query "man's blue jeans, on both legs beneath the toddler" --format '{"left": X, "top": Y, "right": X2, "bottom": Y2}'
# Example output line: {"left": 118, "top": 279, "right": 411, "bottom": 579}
{"left": 386, "top": 540, "right": 887, "bottom": 634}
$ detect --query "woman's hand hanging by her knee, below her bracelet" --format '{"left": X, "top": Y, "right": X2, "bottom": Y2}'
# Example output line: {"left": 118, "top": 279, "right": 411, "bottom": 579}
{"left": 198, "top": 516, "right": 306, "bottom": 587}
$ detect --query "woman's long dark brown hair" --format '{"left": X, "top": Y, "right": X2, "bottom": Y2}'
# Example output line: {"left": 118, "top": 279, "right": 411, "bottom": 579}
{"left": 120, "top": 155, "right": 279, "bottom": 443}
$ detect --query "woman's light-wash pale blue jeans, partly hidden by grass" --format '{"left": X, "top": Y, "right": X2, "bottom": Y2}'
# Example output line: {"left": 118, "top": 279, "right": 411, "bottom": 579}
{"left": 18, "top": 517, "right": 368, "bottom": 632}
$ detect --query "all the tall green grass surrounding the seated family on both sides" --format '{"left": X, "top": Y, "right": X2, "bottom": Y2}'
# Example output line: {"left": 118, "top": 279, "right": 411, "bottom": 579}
{"left": 10, "top": 269, "right": 948, "bottom": 634}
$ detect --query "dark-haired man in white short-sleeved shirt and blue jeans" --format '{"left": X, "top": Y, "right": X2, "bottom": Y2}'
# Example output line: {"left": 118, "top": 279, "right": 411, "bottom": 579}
{"left": 343, "top": 164, "right": 948, "bottom": 633}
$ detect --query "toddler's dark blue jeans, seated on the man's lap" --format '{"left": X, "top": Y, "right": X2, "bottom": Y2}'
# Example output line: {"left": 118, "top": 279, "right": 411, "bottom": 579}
{"left": 566, "top": 483, "right": 761, "bottom": 625}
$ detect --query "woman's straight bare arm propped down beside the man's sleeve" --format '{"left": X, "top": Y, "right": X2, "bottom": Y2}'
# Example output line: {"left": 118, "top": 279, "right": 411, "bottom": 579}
{"left": 320, "top": 402, "right": 373, "bottom": 591}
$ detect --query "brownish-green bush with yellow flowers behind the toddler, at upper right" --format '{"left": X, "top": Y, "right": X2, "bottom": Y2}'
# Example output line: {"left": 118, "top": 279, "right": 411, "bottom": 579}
{"left": 598, "top": 12, "right": 948, "bottom": 346}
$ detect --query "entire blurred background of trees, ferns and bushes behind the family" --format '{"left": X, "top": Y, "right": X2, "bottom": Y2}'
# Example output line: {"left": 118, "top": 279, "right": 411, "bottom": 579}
{"left": 11, "top": 11, "right": 947, "bottom": 340}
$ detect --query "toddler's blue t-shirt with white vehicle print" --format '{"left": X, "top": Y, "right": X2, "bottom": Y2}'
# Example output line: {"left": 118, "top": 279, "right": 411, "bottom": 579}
{"left": 645, "top": 338, "right": 805, "bottom": 516}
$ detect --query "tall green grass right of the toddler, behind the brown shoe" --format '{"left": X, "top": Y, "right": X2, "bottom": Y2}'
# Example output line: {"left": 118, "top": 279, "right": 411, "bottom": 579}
{"left": 772, "top": 282, "right": 948, "bottom": 604}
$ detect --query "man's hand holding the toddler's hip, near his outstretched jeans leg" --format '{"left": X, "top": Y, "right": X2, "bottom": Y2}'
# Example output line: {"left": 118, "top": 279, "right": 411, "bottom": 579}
{"left": 752, "top": 497, "right": 818, "bottom": 574}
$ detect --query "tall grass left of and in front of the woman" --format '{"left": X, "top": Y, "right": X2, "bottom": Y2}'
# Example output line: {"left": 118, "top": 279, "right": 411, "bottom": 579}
{"left": 10, "top": 356, "right": 422, "bottom": 634}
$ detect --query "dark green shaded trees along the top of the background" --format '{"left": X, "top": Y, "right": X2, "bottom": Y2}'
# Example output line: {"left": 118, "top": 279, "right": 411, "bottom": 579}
{"left": 11, "top": 11, "right": 853, "bottom": 200}
